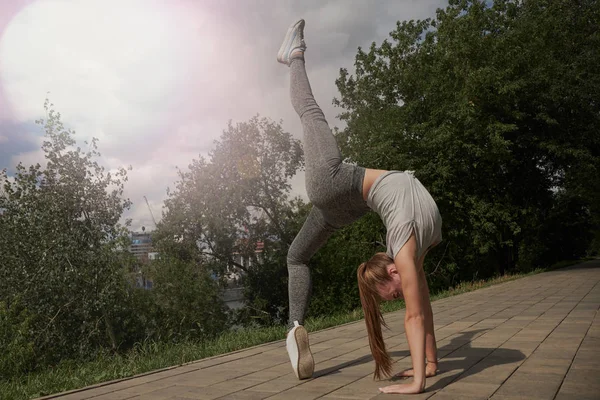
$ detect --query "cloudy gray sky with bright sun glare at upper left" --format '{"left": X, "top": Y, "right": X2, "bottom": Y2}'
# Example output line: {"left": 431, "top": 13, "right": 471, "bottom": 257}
{"left": 0, "top": 0, "right": 447, "bottom": 230}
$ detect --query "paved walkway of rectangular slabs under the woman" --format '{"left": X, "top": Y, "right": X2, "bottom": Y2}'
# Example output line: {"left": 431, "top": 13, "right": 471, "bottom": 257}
{"left": 42, "top": 260, "right": 600, "bottom": 400}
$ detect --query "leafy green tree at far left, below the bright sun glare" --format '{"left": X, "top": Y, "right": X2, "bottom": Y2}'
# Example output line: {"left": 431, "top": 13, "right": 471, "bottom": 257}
{"left": 0, "top": 101, "right": 130, "bottom": 372}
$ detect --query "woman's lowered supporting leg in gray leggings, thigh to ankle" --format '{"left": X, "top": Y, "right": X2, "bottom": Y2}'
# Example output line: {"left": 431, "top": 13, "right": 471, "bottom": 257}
{"left": 287, "top": 207, "right": 335, "bottom": 328}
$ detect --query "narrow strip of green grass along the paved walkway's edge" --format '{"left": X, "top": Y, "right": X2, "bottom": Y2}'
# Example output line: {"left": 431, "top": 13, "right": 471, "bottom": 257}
{"left": 0, "top": 261, "right": 579, "bottom": 400}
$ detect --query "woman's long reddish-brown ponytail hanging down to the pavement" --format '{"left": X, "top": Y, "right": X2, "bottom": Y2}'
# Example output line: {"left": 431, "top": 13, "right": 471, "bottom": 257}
{"left": 356, "top": 253, "right": 394, "bottom": 379}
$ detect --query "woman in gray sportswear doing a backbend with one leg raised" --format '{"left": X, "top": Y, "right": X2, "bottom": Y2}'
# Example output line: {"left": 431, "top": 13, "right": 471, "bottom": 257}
{"left": 277, "top": 20, "right": 442, "bottom": 393}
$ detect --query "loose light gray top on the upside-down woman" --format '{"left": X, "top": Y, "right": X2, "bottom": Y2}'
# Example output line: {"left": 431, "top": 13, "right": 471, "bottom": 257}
{"left": 367, "top": 171, "right": 442, "bottom": 259}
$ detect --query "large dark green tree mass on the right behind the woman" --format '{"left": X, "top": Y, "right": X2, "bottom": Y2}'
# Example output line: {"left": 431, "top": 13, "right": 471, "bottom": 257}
{"left": 334, "top": 0, "right": 600, "bottom": 280}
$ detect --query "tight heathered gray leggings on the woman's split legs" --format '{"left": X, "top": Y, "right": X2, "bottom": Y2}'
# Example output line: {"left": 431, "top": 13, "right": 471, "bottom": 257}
{"left": 287, "top": 58, "right": 369, "bottom": 324}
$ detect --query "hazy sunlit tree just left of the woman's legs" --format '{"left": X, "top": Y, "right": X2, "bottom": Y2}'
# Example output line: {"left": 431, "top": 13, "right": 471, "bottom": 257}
{"left": 155, "top": 116, "right": 305, "bottom": 323}
